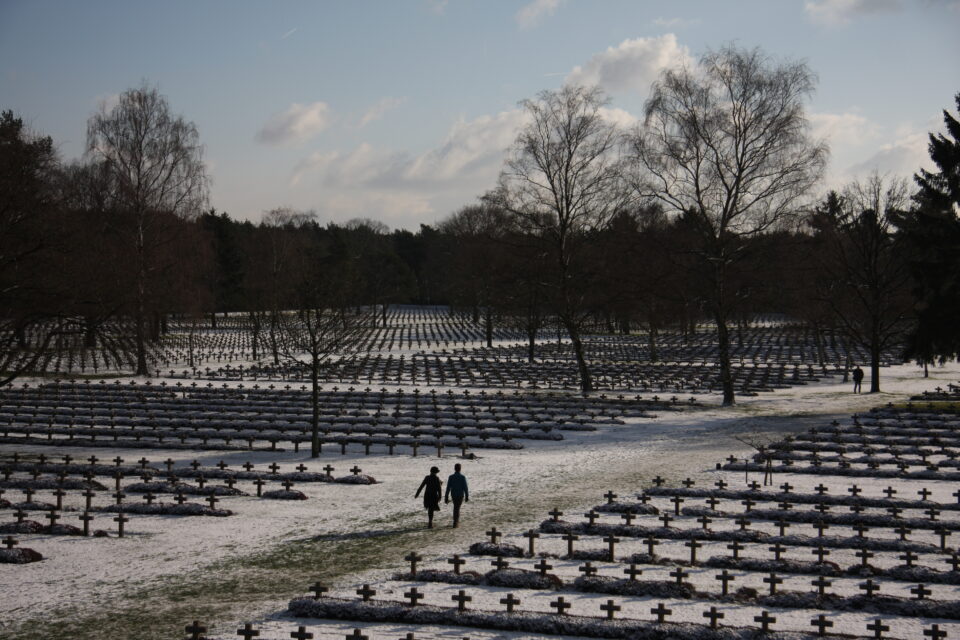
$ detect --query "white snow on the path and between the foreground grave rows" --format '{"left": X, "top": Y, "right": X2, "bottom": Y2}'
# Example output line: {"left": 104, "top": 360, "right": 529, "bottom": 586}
{"left": 0, "top": 356, "right": 960, "bottom": 640}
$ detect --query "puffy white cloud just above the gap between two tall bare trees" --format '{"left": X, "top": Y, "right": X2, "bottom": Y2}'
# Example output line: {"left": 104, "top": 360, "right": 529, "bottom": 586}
{"left": 566, "top": 33, "right": 690, "bottom": 93}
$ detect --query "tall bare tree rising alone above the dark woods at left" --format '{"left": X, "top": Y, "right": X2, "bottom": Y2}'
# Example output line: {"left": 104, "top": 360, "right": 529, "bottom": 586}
{"left": 87, "top": 84, "right": 208, "bottom": 375}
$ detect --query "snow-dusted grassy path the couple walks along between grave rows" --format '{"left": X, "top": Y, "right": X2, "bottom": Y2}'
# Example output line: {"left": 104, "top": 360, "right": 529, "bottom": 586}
{"left": 0, "top": 365, "right": 960, "bottom": 640}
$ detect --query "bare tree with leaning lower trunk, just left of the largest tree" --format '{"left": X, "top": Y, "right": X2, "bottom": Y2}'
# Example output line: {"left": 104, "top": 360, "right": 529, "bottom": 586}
{"left": 488, "top": 86, "right": 626, "bottom": 393}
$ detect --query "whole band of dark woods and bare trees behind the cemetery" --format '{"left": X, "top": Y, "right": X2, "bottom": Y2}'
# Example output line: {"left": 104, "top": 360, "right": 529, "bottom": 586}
{"left": 0, "top": 47, "right": 960, "bottom": 404}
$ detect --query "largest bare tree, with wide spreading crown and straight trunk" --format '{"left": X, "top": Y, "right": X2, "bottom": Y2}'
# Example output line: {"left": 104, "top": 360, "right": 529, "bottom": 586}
{"left": 632, "top": 46, "right": 828, "bottom": 405}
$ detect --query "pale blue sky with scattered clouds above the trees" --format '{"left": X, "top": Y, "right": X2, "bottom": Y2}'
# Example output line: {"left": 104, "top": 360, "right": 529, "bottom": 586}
{"left": 0, "top": 0, "right": 960, "bottom": 229}
